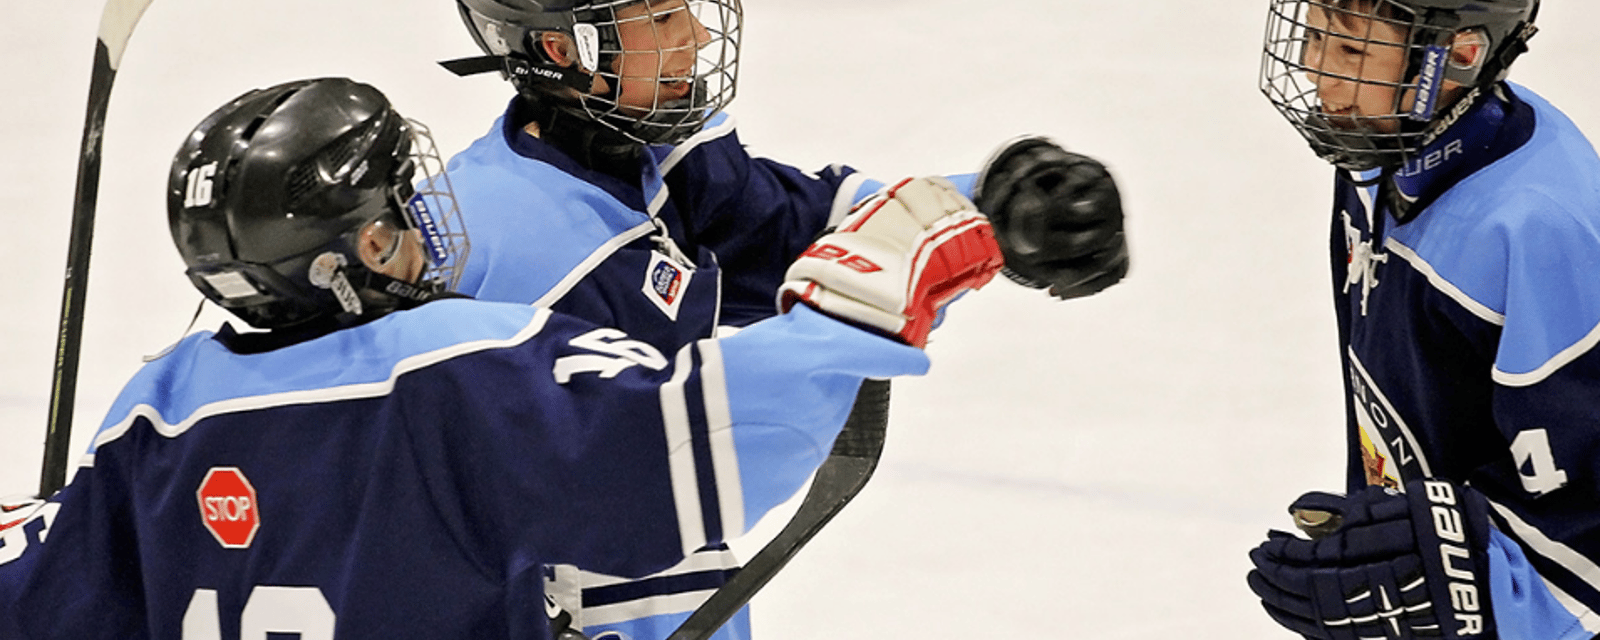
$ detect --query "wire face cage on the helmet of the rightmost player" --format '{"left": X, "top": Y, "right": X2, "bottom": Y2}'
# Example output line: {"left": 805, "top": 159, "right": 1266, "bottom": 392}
{"left": 1261, "top": 0, "right": 1448, "bottom": 171}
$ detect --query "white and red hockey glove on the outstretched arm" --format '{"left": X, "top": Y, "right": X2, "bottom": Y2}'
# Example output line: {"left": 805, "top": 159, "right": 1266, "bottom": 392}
{"left": 778, "top": 178, "right": 1005, "bottom": 347}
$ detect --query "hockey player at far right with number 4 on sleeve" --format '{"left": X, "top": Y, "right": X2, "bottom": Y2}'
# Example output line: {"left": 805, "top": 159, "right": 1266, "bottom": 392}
{"left": 1248, "top": 0, "right": 1600, "bottom": 640}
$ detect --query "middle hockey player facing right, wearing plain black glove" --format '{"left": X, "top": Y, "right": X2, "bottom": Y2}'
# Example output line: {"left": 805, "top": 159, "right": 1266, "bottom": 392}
{"left": 445, "top": 0, "right": 1128, "bottom": 640}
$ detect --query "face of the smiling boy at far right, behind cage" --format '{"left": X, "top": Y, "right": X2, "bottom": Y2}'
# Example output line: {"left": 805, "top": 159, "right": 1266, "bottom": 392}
{"left": 1304, "top": 2, "right": 1406, "bottom": 133}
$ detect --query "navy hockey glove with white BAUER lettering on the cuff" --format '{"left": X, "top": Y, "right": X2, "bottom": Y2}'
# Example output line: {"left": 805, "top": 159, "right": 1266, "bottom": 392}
{"left": 1248, "top": 480, "right": 1496, "bottom": 640}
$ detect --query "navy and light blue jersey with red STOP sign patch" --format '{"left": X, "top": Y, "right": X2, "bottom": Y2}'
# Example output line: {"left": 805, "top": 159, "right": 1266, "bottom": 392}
{"left": 0, "top": 299, "right": 926, "bottom": 640}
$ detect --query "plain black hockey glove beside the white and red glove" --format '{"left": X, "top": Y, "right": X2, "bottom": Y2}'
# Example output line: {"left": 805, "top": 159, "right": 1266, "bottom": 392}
{"left": 973, "top": 138, "right": 1128, "bottom": 299}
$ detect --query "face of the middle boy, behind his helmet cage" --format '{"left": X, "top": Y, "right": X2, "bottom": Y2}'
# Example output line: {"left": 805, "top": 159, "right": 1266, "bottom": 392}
{"left": 613, "top": 0, "right": 712, "bottom": 115}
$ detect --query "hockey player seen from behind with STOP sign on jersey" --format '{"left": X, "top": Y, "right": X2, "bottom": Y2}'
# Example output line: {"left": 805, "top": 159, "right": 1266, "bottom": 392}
{"left": 0, "top": 78, "right": 1002, "bottom": 640}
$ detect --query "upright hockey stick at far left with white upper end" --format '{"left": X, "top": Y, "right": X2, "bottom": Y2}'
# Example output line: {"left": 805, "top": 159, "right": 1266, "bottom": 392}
{"left": 38, "top": 0, "right": 150, "bottom": 498}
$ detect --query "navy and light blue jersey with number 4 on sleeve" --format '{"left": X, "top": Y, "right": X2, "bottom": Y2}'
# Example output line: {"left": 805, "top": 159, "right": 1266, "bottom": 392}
{"left": 1331, "top": 85, "right": 1600, "bottom": 637}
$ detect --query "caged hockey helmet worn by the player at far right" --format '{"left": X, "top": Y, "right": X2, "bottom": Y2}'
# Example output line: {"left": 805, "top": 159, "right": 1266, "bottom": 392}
{"left": 1261, "top": 0, "right": 1539, "bottom": 171}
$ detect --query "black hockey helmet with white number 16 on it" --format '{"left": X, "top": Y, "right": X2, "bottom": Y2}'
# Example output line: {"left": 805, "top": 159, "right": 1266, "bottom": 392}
{"left": 166, "top": 78, "right": 469, "bottom": 328}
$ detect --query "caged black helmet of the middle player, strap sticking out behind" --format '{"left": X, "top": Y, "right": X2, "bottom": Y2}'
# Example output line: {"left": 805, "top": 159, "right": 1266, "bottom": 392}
{"left": 443, "top": 0, "right": 744, "bottom": 144}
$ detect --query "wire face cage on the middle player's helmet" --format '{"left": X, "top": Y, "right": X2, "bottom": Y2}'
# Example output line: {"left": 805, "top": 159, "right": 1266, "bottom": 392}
{"left": 576, "top": 0, "right": 744, "bottom": 144}
